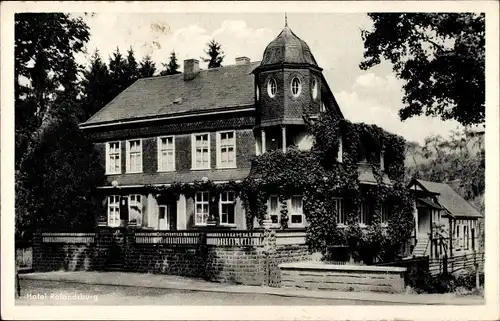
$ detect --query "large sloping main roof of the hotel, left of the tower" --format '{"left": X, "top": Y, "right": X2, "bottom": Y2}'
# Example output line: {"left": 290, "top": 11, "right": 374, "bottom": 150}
{"left": 83, "top": 62, "right": 260, "bottom": 125}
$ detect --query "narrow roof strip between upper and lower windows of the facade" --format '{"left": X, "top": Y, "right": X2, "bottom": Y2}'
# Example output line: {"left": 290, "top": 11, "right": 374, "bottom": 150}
{"left": 107, "top": 168, "right": 250, "bottom": 186}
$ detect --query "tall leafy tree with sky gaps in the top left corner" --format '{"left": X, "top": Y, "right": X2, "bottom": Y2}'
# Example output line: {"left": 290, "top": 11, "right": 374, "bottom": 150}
{"left": 14, "top": 13, "right": 90, "bottom": 168}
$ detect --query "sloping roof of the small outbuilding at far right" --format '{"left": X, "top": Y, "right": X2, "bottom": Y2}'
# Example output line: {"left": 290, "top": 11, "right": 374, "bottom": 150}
{"left": 417, "top": 179, "right": 482, "bottom": 217}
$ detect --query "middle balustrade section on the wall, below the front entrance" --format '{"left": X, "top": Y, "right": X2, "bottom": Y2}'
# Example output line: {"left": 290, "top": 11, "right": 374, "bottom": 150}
{"left": 134, "top": 231, "right": 203, "bottom": 245}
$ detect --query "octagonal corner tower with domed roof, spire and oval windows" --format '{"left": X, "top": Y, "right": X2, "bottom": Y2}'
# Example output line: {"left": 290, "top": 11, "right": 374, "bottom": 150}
{"left": 253, "top": 18, "right": 340, "bottom": 154}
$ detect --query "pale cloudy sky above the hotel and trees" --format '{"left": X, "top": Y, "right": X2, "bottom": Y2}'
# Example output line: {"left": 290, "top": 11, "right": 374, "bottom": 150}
{"left": 77, "top": 13, "right": 459, "bottom": 144}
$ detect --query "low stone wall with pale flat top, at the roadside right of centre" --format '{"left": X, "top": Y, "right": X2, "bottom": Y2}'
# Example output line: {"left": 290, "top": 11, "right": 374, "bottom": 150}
{"left": 279, "top": 262, "right": 406, "bottom": 293}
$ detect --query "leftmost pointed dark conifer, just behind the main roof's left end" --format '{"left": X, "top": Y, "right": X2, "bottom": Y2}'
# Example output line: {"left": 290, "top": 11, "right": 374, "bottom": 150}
{"left": 81, "top": 50, "right": 112, "bottom": 121}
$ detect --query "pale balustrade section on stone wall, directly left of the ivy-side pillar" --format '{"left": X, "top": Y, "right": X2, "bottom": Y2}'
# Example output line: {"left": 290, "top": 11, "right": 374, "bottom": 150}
{"left": 207, "top": 231, "right": 264, "bottom": 246}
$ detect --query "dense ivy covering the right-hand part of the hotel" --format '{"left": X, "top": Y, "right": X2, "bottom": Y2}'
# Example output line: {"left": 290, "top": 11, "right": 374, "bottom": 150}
{"left": 240, "top": 114, "right": 414, "bottom": 264}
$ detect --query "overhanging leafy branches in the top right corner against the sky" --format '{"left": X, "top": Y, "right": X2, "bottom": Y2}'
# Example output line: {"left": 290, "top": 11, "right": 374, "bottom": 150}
{"left": 360, "top": 13, "right": 485, "bottom": 126}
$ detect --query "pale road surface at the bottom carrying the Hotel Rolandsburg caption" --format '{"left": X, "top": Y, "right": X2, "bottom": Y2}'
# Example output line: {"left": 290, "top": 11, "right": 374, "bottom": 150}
{"left": 16, "top": 280, "right": 398, "bottom": 306}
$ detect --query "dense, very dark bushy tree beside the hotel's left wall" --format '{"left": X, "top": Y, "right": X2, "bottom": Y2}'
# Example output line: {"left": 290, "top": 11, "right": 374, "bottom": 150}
{"left": 16, "top": 102, "right": 105, "bottom": 236}
